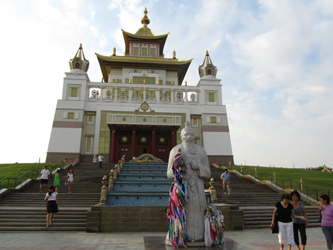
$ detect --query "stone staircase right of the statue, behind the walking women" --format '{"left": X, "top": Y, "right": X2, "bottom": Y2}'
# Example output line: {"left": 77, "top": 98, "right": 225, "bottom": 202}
{"left": 205, "top": 166, "right": 320, "bottom": 229}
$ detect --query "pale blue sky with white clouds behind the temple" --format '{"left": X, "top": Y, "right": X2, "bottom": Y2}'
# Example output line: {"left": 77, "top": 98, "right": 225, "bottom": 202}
{"left": 0, "top": 0, "right": 333, "bottom": 168}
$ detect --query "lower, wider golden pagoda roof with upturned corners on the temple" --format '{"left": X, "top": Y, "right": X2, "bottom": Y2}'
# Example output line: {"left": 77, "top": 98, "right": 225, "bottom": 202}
{"left": 95, "top": 53, "right": 193, "bottom": 85}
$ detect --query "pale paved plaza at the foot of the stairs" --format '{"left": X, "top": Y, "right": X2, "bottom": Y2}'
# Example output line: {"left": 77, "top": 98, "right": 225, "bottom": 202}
{"left": 0, "top": 227, "right": 327, "bottom": 250}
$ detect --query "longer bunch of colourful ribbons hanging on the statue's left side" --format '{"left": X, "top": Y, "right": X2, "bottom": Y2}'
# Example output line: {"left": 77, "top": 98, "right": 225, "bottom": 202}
{"left": 167, "top": 154, "right": 188, "bottom": 247}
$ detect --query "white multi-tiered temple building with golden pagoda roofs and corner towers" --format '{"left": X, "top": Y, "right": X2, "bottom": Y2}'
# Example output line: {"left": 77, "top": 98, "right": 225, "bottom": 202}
{"left": 46, "top": 10, "right": 233, "bottom": 164}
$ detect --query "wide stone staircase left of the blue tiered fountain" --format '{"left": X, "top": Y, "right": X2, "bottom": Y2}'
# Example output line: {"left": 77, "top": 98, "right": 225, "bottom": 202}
{"left": 0, "top": 163, "right": 111, "bottom": 231}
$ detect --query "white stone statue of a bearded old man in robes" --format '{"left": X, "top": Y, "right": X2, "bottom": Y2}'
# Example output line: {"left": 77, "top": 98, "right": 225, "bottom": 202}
{"left": 167, "top": 122, "right": 211, "bottom": 241}
